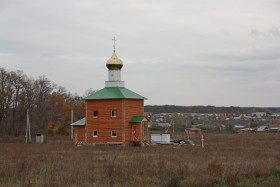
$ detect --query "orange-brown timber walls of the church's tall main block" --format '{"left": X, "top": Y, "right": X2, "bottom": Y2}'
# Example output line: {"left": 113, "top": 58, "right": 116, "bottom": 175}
{"left": 85, "top": 99, "right": 144, "bottom": 144}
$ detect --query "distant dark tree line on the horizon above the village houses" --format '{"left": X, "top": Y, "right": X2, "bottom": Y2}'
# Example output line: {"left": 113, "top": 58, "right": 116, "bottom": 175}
{"left": 145, "top": 105, "right": 280, "bottom": 114}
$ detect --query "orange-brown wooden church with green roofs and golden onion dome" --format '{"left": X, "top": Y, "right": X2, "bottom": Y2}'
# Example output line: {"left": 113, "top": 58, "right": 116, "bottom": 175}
{"left": 71, "top": 39, "right": 149, "bottom": 145}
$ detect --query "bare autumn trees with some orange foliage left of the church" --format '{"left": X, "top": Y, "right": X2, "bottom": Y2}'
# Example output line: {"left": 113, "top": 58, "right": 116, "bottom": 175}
{"left": 0, "top": 67, "right": 85, "bottom": 135}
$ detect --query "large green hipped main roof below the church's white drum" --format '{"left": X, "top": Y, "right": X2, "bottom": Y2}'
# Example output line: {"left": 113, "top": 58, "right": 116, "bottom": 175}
{"left": 84, "top": 87, "right": 147, "bottom": 100}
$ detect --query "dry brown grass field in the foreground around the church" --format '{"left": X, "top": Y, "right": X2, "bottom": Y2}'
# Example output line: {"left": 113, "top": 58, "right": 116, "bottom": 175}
{"left": 0, "top": 134, "right": 280, "bottom": 187}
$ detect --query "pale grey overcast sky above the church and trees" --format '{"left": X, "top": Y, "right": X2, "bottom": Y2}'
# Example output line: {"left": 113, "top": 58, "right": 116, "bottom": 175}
{"left": 0, "top": 0, "right": 280, "bottom": 107}
